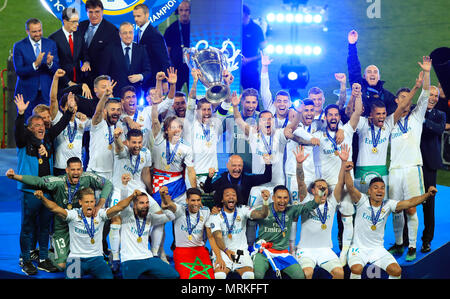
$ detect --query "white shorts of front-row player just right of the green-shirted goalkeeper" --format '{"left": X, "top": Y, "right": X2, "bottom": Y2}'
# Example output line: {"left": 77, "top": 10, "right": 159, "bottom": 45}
{"left": 295, "top": 248, "right": 342, "bottom": 272}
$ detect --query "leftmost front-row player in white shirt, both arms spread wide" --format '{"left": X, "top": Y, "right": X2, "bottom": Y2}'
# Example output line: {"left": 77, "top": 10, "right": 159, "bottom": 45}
{"left": 34, "top": 188, "right": 135, "bottom": 279}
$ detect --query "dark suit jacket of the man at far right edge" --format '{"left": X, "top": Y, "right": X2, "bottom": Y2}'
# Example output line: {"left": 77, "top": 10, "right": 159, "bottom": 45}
{"left": 420, "top": 109, "right": 445, "bottom": 170}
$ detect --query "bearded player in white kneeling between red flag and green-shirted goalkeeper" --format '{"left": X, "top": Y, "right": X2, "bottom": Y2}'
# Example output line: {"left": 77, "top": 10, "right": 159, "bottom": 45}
{"left": 210, "top": 185, "right": 270, "bottom": 279}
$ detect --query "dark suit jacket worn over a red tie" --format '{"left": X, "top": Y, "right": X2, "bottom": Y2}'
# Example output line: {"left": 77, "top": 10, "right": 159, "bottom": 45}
{"left": 48, "top": 29, "right": 84, "bottom": 90}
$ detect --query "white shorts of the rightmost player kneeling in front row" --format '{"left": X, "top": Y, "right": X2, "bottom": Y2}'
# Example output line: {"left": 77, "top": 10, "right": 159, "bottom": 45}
{"left": 348, "top": 246, "right": 397, "bottom": 271}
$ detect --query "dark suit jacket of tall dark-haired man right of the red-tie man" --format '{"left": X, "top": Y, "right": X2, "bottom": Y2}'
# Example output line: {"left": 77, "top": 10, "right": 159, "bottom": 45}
{"left": 78, "top": 18, "right": 120, "bottom": 90}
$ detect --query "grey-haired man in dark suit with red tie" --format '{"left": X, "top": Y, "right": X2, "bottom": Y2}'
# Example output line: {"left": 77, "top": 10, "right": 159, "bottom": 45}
{"left": 49, "top": 7, "right": 92, "bottom": 99}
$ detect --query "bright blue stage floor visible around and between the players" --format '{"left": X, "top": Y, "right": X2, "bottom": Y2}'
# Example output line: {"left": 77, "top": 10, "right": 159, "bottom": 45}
{"left": 0, "top": 149, "right": 450, "bottom": 279}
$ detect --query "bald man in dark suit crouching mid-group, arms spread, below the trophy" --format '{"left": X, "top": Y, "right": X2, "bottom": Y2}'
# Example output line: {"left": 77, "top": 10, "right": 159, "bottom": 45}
{"left": 203, "top": 155, "right": 272, "bottom": 205}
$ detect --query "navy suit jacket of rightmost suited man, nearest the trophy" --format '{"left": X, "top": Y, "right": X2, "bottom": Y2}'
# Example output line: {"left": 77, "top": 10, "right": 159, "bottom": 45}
{"left": 139, "top": 24, "right": 170, "bottom": 90}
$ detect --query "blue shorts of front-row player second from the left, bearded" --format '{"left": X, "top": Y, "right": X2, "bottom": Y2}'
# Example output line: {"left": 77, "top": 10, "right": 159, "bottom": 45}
{"left": 121, "top": 257, "right": 180, "bottom": 279}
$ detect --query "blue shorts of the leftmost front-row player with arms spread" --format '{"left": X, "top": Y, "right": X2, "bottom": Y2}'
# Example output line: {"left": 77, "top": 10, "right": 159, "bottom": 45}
{"left": 66, "top": 256, "right": 114, "bottom": 279}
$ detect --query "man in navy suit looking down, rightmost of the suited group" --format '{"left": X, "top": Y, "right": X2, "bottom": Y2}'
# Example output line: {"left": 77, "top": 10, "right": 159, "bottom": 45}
{"left": 133, "top": 4, "right": 171, "bottom": 92}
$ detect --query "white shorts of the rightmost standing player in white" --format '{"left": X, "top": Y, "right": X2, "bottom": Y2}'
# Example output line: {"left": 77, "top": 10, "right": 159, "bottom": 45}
{"left": 389, "top": 166, "right": 425, "bottom": 201}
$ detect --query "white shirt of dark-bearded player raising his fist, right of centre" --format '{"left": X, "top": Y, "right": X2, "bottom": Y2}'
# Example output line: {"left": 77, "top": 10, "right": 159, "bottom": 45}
{"left": 313, "top": 123, "right": 354, "bottom": 185}
